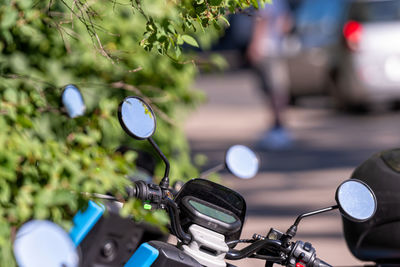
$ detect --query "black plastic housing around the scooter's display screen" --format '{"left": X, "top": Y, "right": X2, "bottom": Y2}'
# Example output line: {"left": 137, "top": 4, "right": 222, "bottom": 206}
{"left": 175, "top": 178, "right": 246, "bottom": 248}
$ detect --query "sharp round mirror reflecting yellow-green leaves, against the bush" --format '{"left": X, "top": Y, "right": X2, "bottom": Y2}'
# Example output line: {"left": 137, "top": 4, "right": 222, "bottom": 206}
{"left": 118, "top": 96, "right": 156, "bottom": 140}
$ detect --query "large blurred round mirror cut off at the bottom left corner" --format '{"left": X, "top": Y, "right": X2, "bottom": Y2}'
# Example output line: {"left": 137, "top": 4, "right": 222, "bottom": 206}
{"left": 14, "top": 220, "right": 79, "bottom": 267}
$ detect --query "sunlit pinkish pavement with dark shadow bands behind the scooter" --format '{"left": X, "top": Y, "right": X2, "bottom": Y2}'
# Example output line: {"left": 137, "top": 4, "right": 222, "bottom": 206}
{"left": 185, "top": 71, "right": 400, "bottom": 266}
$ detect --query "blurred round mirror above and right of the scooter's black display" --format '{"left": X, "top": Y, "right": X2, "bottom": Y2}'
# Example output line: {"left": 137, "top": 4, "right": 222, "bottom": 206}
{"left": 225, "top": 145, "right": 259, "bottom": 179}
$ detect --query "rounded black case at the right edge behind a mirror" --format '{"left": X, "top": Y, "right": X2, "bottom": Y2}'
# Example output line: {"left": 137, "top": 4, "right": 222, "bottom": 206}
{"left": 343, "top": 149, "right": 400, "bottom": 263}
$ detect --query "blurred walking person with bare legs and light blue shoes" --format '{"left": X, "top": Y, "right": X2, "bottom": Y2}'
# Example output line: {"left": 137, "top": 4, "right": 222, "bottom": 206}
{"left": 247, "top": 0, "right": 292, "bottom": 149}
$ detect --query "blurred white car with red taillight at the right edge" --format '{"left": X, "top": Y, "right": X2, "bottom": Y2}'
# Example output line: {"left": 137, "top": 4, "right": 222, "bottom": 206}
{"left": 336, "top": 0, "right": 400, "bottom": 110}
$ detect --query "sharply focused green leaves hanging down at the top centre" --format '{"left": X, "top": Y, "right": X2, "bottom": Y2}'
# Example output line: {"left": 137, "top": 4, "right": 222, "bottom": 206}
{"left": 117, "top": 0, "right": 271, "bottom": 58}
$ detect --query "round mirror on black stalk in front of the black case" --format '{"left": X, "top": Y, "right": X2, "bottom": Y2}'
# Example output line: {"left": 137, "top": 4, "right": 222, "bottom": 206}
{"left": 336, "top": 179, "right": 377, "bottom": 222}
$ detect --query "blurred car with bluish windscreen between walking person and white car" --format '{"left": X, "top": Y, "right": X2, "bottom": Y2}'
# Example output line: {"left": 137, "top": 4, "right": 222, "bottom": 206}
{"left": 285, "top": 0, "right": 344, "bottom": 102}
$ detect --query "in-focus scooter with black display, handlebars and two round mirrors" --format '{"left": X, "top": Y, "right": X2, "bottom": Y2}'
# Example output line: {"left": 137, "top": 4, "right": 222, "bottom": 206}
{"left": 14, "top": 97, "right": 377, "bottom": 267}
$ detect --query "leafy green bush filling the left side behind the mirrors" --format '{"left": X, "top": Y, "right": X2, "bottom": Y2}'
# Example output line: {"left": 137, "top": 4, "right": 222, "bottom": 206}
{"left": 0, "top": 0, "right": 268, "bottom": 266}
